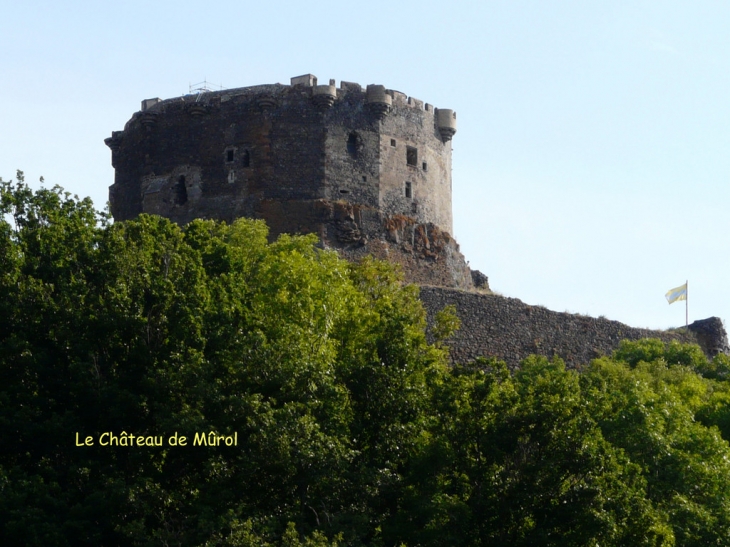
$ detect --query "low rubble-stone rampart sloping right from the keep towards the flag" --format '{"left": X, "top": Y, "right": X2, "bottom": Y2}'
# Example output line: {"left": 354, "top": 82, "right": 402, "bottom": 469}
{"left": 421, "top": 287, "right": 730, "bottom": 369}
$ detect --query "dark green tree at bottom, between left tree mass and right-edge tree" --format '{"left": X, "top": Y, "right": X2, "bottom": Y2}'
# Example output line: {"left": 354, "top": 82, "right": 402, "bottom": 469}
{"left": 398, "top": 357, "right": 673, "bottom": 546}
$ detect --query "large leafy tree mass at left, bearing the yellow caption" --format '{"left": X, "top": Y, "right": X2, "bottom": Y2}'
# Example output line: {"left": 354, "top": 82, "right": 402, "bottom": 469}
{"left": 0, "top": 180, "right": 444, "bottom": 545}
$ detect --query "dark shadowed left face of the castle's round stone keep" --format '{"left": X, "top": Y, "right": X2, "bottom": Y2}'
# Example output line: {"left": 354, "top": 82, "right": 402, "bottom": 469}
{"left": 106, "top": 84, "right": 325, "bottom": 224}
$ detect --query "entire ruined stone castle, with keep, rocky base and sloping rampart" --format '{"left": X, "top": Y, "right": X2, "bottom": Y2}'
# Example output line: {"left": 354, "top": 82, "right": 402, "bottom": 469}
{"left": 105, "top": 74, "right": 730, "bottom": 367}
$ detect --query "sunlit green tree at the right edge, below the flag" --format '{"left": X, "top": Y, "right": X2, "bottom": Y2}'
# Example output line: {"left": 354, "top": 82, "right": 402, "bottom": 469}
{"left": 581, "top": 341, "right": 730, "bottom": 546}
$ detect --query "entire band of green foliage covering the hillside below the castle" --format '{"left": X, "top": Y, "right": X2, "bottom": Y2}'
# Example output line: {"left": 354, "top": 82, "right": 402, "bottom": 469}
{"left": 0, "top": 174, "right": 730, "bottom": 547}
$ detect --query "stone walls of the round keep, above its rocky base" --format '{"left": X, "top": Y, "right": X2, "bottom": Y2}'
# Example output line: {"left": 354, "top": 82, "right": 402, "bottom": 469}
{"left": 105, "top": 77, "right": 452, "bottom": 232}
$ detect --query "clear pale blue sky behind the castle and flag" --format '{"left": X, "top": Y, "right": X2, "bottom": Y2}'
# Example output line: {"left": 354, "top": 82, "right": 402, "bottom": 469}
{"left": 0, "top": 0, "right": 730, "bottom": 328}
